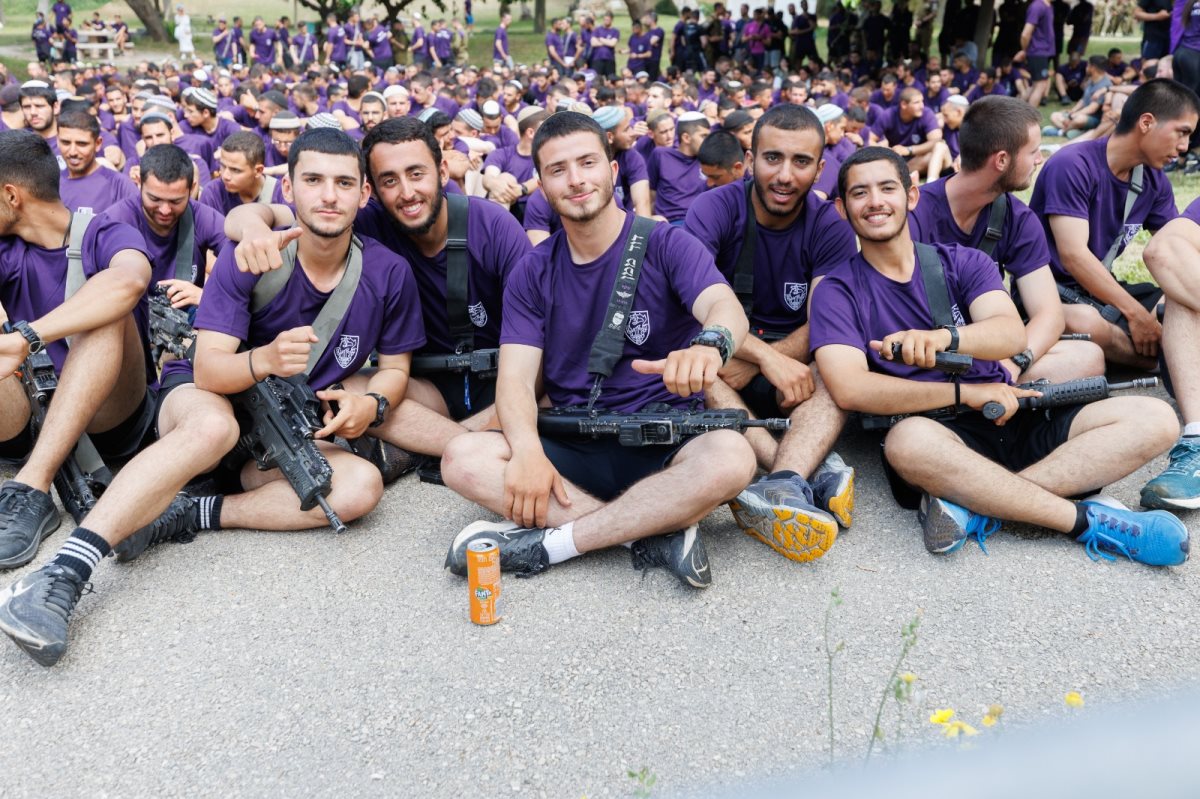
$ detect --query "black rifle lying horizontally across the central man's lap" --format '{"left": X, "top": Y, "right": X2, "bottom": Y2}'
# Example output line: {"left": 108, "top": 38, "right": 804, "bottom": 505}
{"left": 538, "top": 407, "right": 791, "bottom": 446}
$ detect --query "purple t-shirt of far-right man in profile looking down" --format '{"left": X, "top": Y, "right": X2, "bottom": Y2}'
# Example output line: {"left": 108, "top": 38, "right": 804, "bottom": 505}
{"left": 1030, "top": 136, "right": 1178, "bottom": 286}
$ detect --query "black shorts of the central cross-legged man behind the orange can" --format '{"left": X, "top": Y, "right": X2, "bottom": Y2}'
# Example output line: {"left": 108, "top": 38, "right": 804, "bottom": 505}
{"left": 541, "top": 435, "right": 691, "bottom": 503}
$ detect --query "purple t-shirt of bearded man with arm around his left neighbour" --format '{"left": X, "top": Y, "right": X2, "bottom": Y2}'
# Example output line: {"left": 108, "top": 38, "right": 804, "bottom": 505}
{"left": 354, "top": 197, "right": 529, "bottom": 353}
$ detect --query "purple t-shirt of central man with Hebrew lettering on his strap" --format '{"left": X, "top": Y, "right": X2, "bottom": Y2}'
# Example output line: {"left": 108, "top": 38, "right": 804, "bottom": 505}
{"left": 500, "top": 214, "right": 725, "bottom": 411}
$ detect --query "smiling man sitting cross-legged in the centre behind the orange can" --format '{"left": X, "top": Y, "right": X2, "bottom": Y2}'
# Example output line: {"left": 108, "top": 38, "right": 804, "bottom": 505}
{"left": 442, "top": 112, "right": 755, "bottom": 588}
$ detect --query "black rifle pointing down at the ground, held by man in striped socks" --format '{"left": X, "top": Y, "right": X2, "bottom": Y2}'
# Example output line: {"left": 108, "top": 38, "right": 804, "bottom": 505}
{"left": 232, "top": 374, "right": 346, "bottom": 533}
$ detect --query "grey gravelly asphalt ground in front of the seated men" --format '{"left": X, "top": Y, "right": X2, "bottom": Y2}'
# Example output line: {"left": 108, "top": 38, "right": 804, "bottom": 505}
{"left": 0, "top": 386, "right": 1200, "bottom": 797}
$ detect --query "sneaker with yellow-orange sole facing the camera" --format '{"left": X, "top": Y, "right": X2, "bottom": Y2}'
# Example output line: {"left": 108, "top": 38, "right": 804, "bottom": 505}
{"left": 730, "top": 477, "right": 838, "bottom": 563}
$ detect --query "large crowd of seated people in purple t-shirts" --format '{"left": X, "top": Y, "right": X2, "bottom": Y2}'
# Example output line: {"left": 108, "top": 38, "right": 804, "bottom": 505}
{"left": 0, "top": 0, "right": 1200, "bottom": 666}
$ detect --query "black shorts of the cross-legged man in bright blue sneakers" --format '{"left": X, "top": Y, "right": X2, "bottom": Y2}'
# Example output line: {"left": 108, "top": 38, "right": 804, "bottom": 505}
{"left": 881, "top": 405, "right": 1085, "bottom": 509}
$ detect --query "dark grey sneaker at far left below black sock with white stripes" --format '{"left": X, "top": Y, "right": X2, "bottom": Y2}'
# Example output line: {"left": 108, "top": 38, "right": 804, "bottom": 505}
{"left": 0, "top": 563, "right": 85, "bottom": 666}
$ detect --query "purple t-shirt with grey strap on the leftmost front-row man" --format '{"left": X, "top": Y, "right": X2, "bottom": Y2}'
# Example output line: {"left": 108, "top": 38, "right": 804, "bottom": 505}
{"left": 0, "top": 216, "right": 146, "bottom": 372}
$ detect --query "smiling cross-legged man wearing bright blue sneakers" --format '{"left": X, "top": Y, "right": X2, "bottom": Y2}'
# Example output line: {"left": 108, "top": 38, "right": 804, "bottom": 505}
{"left": 811, "top": 148, "right": 1188, "bottom": 566}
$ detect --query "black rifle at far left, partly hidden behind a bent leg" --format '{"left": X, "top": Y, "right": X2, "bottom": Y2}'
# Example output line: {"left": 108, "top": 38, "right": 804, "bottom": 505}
{"left": 17, "top": 350, "right": 113, "bottom": 524}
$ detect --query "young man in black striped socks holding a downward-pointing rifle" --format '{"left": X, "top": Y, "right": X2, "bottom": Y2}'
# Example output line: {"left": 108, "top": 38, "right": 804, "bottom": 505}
{"left": 0, "top": 128, "right": 425, "bottom": 666}
